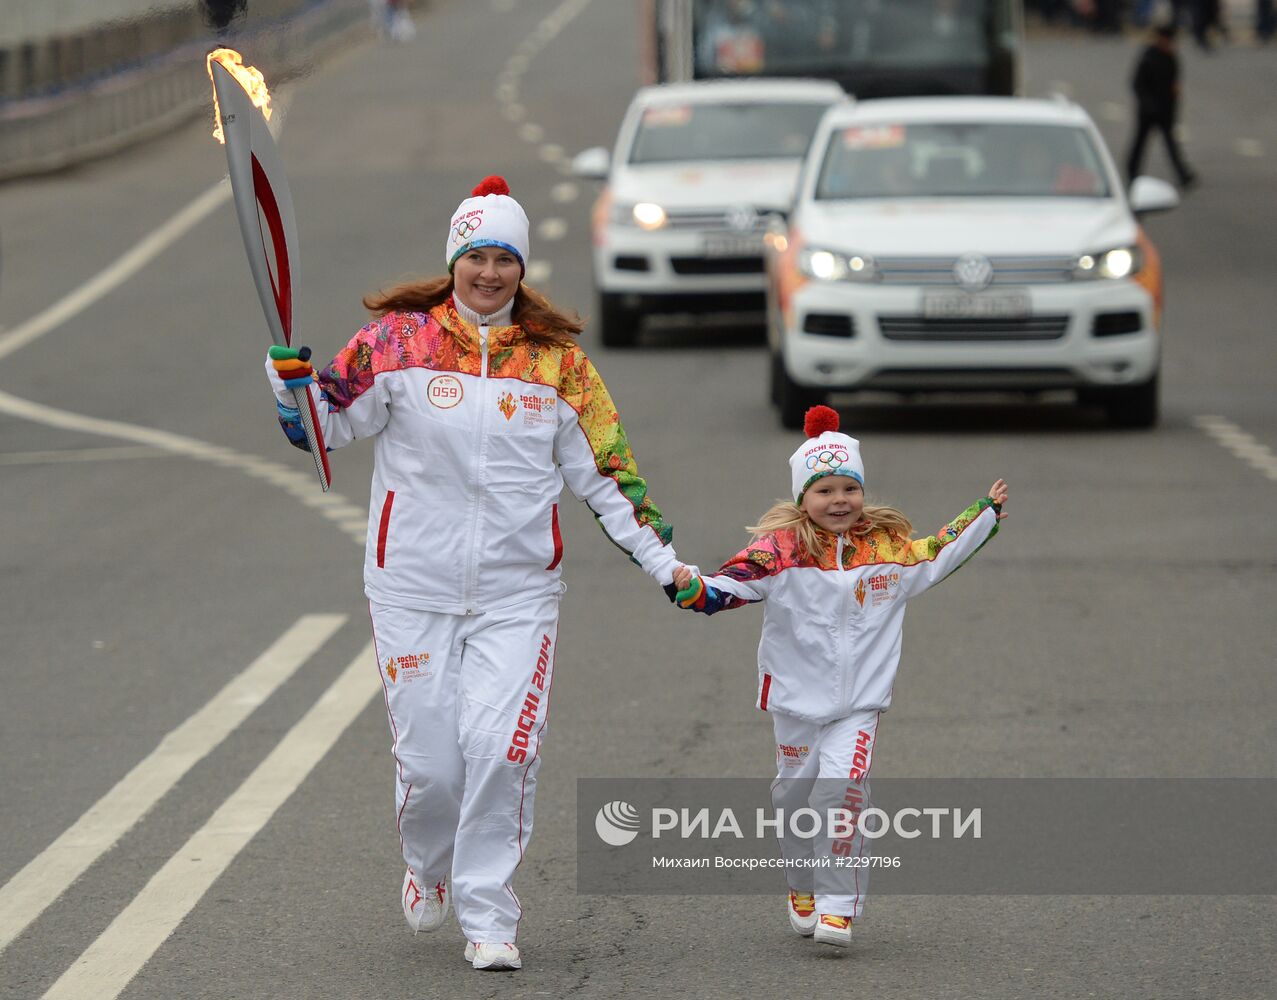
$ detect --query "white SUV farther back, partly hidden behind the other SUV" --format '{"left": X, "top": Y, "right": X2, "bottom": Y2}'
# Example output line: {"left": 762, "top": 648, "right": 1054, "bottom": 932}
{"left": 572, "top": 79, "right": 845, "bottom": 347}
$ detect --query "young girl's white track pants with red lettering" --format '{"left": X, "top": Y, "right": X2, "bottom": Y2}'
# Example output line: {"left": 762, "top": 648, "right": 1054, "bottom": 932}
{"left": 771, "top": 709, "right": 881, "bottom": 917}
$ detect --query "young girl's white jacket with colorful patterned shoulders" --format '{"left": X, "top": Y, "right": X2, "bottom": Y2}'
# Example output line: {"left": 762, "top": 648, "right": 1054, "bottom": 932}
{"left": 695, "top": 498, "right": 997, "bottom": 723}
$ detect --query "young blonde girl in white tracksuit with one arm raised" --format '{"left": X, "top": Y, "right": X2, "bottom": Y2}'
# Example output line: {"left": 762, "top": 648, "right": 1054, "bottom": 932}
{"left": 674, "top": 406, "right": 1008, "bottom": 948}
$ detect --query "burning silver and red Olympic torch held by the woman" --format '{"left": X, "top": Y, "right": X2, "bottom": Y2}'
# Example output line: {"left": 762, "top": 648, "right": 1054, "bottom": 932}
{"left": 208, "top": 49, "right": 332, "bottom": 493}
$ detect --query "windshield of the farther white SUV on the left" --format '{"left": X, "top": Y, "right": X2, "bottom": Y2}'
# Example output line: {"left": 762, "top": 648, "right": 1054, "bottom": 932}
{"left": 630, "top": 101, "right": 825, "bottom": 163}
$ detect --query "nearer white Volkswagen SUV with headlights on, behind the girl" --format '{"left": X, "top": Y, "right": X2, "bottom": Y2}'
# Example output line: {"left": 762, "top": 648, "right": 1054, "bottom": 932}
{"left": 767, "top": 97, "right": 1179, "bottom": 427}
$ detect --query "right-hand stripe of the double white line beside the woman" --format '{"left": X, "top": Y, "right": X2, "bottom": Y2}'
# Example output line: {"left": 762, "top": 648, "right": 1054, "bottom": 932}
{"left": 45, "top": 642, "right": 381, "bottom": 1000}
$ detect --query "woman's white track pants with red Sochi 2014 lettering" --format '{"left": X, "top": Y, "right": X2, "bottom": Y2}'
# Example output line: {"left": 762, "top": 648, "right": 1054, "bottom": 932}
{"left": 369, "top": 595, "right": 559, "bottom": 941}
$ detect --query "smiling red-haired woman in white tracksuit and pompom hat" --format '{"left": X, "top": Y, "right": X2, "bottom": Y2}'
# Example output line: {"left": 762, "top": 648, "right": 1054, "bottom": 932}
{"left": 267, "top": 178, "right": 677, "bottom": 968}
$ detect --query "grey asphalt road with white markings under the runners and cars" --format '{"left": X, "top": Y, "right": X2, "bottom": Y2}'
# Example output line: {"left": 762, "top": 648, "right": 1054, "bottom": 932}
{"left": 0, "top": 0, "right": 1277, "bottom": 1000}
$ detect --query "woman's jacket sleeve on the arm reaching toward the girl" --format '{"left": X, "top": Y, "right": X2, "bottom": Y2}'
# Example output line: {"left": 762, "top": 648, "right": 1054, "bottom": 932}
{"left": 555, "top": 349, "right": 677, "bottom": 584}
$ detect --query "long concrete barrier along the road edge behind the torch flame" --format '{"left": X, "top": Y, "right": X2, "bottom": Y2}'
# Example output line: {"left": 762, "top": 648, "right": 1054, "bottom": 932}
{"left": 0, "top": 0, "right": 369, "bottom": 180}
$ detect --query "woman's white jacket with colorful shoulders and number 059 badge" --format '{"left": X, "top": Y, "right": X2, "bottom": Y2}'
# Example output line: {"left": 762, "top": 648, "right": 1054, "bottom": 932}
{"left": 267, "top": 300, "right": 677, "bottom": 614}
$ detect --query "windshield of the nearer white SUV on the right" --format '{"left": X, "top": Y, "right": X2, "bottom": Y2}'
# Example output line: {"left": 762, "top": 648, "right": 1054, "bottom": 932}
{"left": 816, "top": 123, "right": 1108, "bottom": 199}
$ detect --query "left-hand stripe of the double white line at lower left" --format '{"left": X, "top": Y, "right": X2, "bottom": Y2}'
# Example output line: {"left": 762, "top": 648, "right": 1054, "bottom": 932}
{"left": 0, "top": 614, "right": 346, "bottom": 960}
